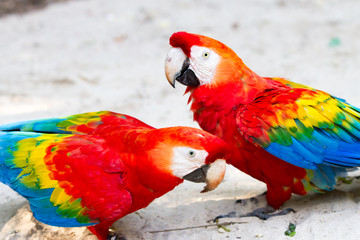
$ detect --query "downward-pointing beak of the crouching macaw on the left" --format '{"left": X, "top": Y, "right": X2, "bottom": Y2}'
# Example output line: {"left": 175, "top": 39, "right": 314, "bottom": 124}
{"left": 183, "top": 159, "right": 226, "bottom": 193}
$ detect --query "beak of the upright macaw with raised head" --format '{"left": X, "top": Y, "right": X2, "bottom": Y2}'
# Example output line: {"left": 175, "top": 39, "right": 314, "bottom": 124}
{"left": 165, "top": 48, "right": 200, "bottom": 88}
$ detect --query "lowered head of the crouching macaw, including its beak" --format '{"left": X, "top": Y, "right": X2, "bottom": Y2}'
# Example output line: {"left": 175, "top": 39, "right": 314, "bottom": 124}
{"left": 150, "top": 127, "right": 228, "bottom": 192}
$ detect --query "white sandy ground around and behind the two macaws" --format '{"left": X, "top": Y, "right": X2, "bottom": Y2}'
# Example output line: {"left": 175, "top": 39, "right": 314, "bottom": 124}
{"left": 0, "top": 0, "right": 360, "bottom": 239}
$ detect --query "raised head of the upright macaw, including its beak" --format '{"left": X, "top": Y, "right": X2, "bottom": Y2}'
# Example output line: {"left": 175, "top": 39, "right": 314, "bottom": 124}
{"left": 165, "top": 32, "right": 251, "bottom": 87}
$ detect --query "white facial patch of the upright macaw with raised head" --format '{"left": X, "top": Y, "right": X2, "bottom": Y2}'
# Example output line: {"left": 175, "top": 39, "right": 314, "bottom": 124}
{"left": 189, "top": 46, "right": 220, "bottom": 85}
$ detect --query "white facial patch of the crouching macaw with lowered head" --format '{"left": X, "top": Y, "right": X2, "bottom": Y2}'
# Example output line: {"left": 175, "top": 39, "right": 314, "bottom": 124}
{"left": 171, "top": 147, "right": 208, "bottom": 178}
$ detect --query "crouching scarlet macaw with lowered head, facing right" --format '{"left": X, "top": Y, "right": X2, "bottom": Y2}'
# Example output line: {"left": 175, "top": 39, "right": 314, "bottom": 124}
{"left": 0, "top": 111, "right": 227, "bottom": 240}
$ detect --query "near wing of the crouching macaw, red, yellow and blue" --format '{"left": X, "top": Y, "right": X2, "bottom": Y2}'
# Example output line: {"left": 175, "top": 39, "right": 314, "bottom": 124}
{"left": 0, "top": 132, "right": 131, "bottom": 227}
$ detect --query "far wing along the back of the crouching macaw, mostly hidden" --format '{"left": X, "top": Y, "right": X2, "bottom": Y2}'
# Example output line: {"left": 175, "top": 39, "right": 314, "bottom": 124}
{"left": 0, "top": 111, "right": 152, "bottom": 134}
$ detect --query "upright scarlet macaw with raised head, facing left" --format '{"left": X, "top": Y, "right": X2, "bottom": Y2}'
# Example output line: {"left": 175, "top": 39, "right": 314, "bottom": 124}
{"left": 165, "top": 32, "right": 360, "bottom": 217}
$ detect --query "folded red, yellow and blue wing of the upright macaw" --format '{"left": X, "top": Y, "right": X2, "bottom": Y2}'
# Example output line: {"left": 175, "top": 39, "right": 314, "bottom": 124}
{"left": 236, "top": 88, "right": 360, "bottom": 169}
